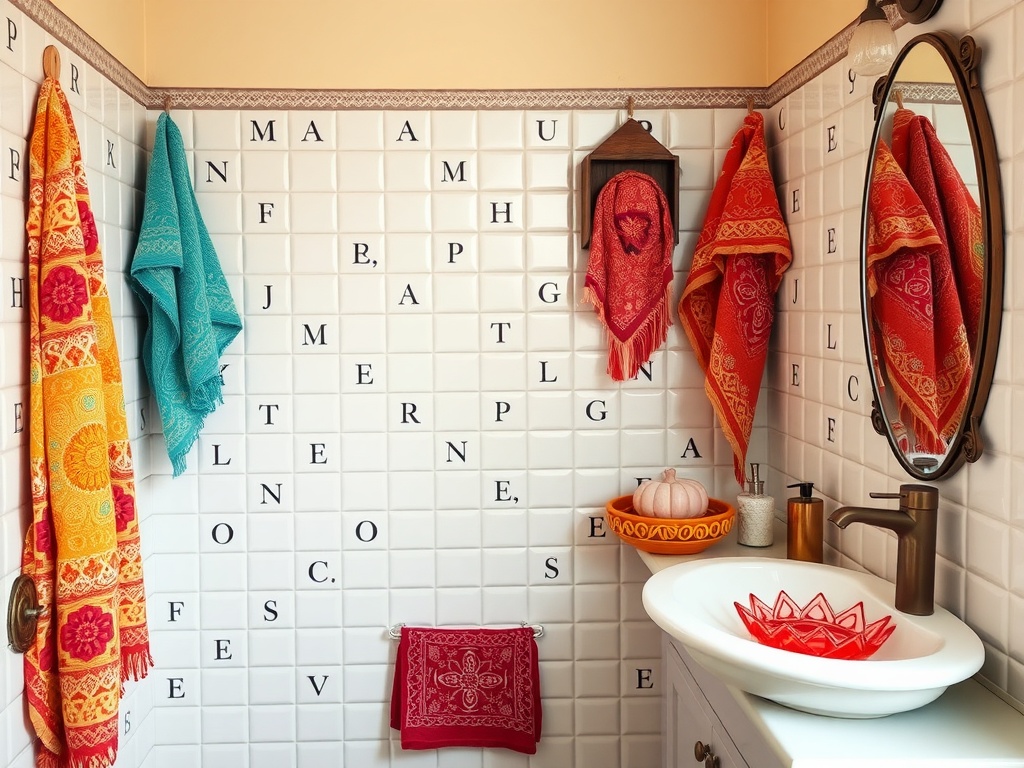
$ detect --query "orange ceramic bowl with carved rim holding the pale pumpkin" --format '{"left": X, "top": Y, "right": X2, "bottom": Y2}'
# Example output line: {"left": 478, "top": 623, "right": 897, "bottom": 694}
{"left": 605, "top": 495, "right": 736, "bottom": 555}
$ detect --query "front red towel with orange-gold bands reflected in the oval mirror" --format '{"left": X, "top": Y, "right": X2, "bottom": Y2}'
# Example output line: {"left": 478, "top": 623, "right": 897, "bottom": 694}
{"left": 866, "top": 140, "right": 971, "bottom": 454}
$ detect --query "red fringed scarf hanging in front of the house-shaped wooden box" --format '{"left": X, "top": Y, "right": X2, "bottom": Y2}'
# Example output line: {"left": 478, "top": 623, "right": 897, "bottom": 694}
{"left": 583, "top": 171, "right": 676, "bottom": 381}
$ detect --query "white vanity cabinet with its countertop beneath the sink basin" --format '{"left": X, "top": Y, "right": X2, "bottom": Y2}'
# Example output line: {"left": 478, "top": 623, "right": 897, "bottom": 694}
{"left": 662, "top": 634, "right": 1024, "bottom": 768}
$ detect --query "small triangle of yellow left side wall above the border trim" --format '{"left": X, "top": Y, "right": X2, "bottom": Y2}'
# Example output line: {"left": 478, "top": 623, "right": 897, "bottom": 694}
{"left": 51, "top": 0, "right": 146, "bottom": 82}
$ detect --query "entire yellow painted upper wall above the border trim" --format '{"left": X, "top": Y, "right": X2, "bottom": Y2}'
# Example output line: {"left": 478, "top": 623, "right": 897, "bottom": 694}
{"left": 53, "top": 0, "right": 863, "bottom": 89}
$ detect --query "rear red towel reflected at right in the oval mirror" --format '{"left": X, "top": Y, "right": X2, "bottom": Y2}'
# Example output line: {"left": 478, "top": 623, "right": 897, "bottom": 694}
{"left": 892, "top": 110, "right": 985, "bottom": 354}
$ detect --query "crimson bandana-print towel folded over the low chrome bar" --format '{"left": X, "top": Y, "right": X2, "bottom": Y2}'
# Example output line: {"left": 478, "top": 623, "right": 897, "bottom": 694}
{"left": 391, "top": 627, "right": 541, "bottom": 755}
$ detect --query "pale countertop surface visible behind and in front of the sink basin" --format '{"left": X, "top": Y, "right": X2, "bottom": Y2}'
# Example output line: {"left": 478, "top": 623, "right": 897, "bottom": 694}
{"left": 640, "top": 519, "right": 1024, "bottom": 768}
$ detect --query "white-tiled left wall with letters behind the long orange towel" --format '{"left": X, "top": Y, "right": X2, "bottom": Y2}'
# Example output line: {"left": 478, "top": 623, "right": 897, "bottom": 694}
{"left": 0, "top": 2, "right": 155, "bottom": 768}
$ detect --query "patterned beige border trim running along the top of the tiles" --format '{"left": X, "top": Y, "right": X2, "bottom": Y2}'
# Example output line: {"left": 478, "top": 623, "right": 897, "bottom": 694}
{"left": 10, "top": 0, "right": 904, "bottom": 111}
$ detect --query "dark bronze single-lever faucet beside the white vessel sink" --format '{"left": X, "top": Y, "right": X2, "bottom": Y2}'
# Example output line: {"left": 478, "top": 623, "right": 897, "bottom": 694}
{"left": 828, "top": 483, "right": 939, "bottom": 616}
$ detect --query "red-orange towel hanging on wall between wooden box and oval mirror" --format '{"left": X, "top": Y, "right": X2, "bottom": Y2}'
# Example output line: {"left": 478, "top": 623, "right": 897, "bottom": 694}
{"left": 679, "top": 112, "right": 793, "bottom": 487}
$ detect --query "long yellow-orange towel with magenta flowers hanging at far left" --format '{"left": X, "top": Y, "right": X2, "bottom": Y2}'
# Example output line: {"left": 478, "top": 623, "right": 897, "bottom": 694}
{"left": 22, "top": 78, "right": 152, "bottom": 768}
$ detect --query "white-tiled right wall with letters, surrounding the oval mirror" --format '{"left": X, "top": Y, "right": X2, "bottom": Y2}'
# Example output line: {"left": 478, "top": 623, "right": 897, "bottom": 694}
{"left": 768, "top": 0, "right": 1024, "bottom": 709}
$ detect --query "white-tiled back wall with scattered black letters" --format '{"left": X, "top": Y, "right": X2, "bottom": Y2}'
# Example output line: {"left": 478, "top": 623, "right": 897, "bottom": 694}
{"left": 140, "top": 103, "right": 740, "bottom": 768}
